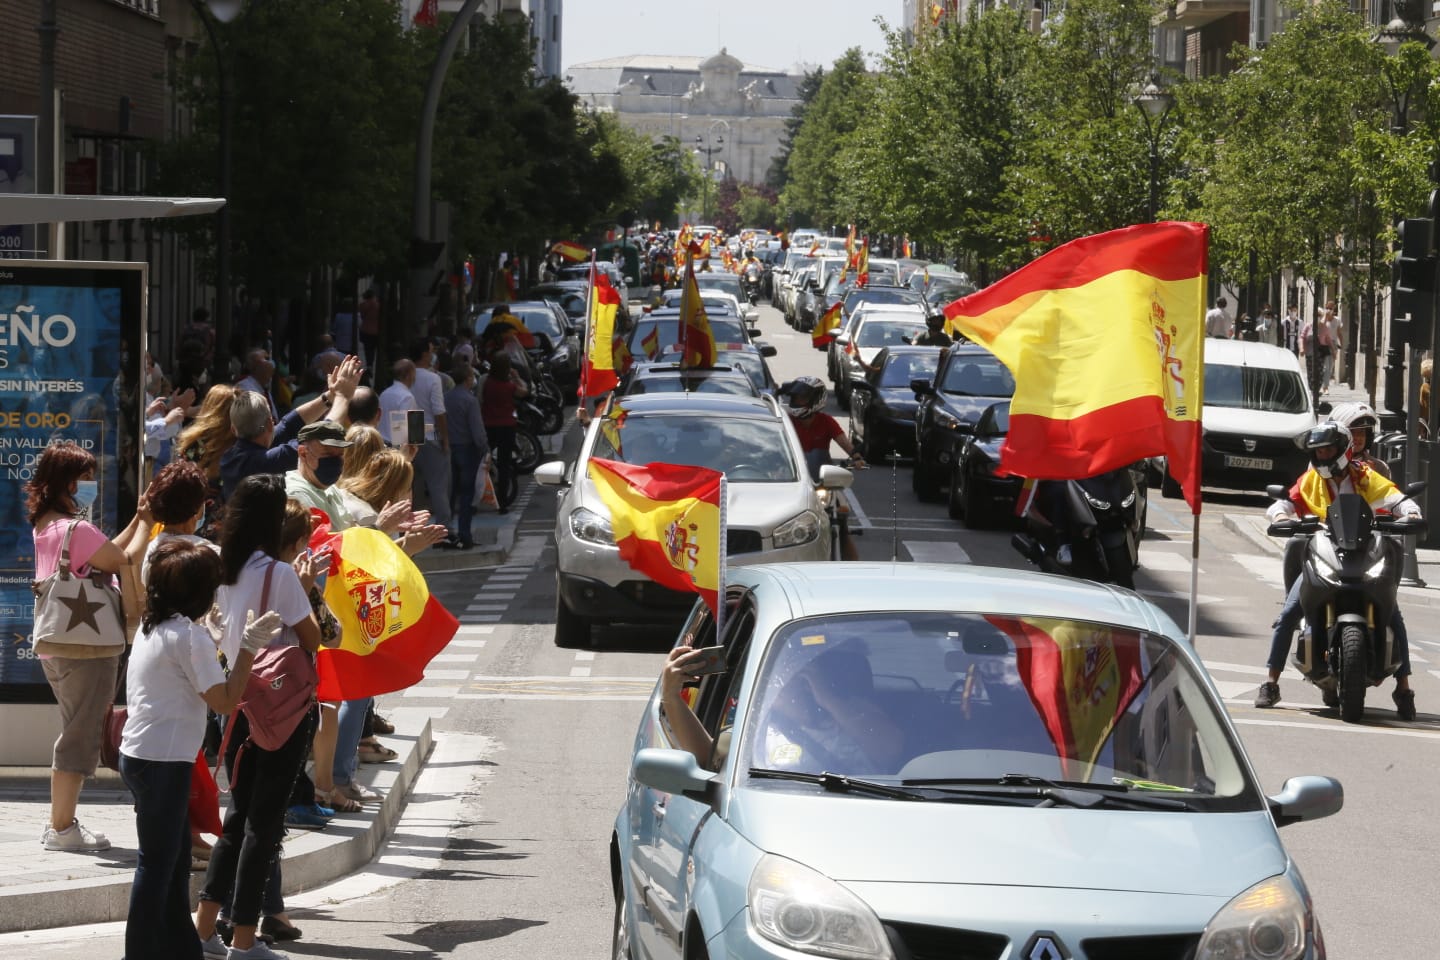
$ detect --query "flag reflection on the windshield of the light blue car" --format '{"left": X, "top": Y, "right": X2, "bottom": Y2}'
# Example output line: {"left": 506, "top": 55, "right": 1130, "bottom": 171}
{"left": 985, "top": 616, "right": 1146, "bottom": 780}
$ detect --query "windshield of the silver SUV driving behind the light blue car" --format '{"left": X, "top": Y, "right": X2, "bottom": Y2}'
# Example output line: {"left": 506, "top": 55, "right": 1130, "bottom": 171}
{"left": 590, "top": 413, "right": 796, "bottom": 484}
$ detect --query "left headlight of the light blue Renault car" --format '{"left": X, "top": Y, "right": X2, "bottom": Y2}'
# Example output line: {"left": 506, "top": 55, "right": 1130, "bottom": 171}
{"left": 747, "top": 853, "right": 894, "bottom": 960}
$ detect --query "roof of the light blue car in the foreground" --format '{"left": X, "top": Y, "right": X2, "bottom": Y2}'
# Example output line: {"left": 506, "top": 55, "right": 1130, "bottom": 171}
{"left": 726, "top": 561, "right": 1185, "bottom": 640}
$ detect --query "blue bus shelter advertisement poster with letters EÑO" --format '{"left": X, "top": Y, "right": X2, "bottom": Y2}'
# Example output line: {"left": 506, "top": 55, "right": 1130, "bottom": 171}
{"left": 0, "top": 259, "right": 145, "bottom": 702}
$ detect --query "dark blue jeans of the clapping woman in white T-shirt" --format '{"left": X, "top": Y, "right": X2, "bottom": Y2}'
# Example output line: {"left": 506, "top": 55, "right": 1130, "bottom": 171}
{"left": 120, "top": 754, "right": 200, "bottom": 960}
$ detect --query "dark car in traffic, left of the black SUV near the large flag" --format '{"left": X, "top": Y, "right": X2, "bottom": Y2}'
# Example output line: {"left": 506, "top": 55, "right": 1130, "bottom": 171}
{"left": 850, "top": 347, "right": 940, "bottom": 461}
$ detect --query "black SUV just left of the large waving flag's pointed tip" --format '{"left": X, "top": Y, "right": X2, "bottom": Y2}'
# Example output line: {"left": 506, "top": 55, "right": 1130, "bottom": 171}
{"left": 910, "top": 344, "right": 1015, "bottom": 499}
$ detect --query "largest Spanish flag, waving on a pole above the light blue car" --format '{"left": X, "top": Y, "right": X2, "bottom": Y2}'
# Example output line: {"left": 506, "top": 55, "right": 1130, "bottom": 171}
{"left": 945, "top": 223, "right": 1210, "bottom": 514}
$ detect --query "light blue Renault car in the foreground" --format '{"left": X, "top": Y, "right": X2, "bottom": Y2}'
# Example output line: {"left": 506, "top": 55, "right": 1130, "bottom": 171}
{"left": 611, "top": 563, "right": 1344, "bottom": 960}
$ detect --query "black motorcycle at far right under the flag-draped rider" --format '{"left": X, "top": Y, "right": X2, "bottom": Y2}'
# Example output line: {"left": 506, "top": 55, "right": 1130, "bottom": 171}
{"left": 1266, "top": 481, "right": 1426, "bottom": 724}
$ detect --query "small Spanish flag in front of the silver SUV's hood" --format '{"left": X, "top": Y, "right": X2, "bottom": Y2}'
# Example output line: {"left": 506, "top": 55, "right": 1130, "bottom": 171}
{"left": 589, "top": 458, "right": 726, "bottom": 619}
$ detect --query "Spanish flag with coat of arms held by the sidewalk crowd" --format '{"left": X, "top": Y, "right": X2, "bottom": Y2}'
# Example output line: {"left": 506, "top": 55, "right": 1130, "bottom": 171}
{"left": 310, "top": 521, "right": 459, "bottom": 699}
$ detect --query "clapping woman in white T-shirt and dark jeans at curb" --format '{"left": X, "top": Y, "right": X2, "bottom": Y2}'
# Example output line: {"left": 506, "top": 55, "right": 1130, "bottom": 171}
{"left": 120, "top": 538, "right": 279, "bottom": 960}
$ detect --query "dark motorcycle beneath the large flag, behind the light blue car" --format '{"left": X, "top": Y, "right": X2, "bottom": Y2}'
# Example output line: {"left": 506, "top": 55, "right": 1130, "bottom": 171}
{"left": 1011, "top": 466, "right": 1143, "bottom": 590}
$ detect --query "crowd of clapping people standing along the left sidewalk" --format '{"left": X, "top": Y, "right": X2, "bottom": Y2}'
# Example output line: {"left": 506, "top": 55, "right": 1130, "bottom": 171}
{"left": 26, "top": 318, "right": 547, "bottom": 960}
